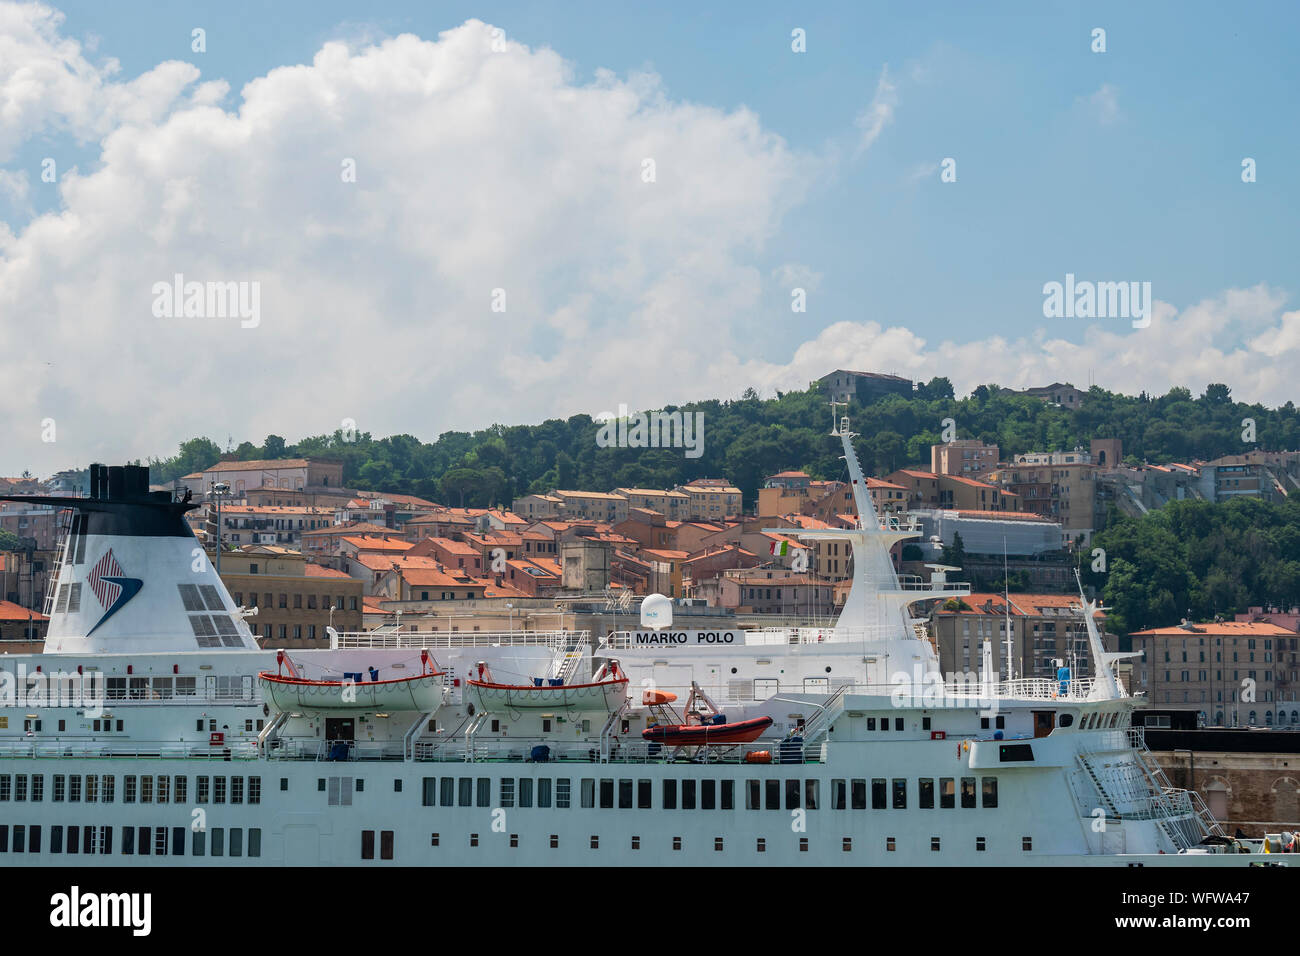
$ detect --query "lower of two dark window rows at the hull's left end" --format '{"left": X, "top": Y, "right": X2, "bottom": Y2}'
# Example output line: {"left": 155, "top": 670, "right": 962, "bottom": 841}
{"left": 0, "top": 823, "right": 261, "bottom": 857}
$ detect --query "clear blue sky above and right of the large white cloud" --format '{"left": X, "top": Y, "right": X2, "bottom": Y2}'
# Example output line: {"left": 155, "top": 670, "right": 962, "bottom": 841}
{"left": 30, "top": 0, "right": 1300, "bottom": 360}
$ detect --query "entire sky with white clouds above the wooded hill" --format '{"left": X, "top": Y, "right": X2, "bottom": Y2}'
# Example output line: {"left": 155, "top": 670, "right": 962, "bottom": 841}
{"left": 0, "top": 0, "right": 1300, "bottom": 476}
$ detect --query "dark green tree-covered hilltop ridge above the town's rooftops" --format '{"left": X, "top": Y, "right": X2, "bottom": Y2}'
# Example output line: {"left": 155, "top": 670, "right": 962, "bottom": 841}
{"left": 150, "top": 378, "right": 1300, "bottom": 507}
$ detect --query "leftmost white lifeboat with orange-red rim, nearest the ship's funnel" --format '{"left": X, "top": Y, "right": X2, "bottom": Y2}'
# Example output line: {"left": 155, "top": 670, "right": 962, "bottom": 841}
{"left": 257, "top": 650, "right": 445, "bottom": 714}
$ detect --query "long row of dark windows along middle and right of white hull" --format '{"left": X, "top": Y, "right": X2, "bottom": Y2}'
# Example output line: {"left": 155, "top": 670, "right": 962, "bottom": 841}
{"left": 423, "top": 777, "right": 997, "bottom": 810}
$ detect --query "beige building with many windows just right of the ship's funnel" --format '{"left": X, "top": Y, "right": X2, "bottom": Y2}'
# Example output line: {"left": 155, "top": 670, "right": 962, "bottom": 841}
{"left": 212, "top": 545, "right": 363, "bottom": 648}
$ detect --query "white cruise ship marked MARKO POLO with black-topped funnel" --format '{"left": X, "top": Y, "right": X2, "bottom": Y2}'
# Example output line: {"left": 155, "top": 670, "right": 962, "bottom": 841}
{"left": 0, "top": 410, "right": 1288, "bottom": 866}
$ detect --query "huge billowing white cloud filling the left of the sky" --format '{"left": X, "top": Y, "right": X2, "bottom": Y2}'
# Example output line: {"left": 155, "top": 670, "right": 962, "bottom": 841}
{"left": 0, "top": 13, "right": 818, "bottom": 473}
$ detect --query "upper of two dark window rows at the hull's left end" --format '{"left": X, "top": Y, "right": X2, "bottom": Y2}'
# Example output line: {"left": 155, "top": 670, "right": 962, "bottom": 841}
{"left": 0, "top": 774, "right": 261, "bottom": 804}
